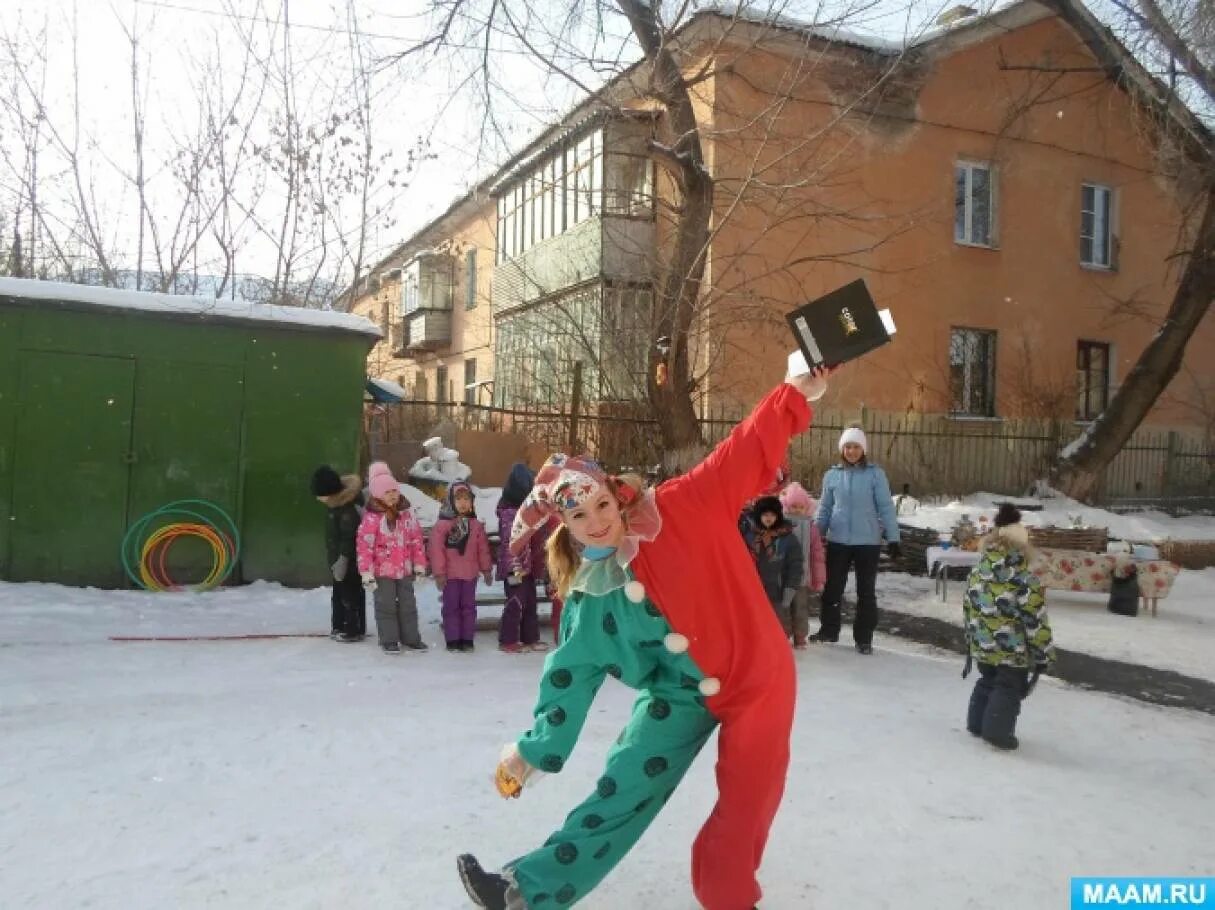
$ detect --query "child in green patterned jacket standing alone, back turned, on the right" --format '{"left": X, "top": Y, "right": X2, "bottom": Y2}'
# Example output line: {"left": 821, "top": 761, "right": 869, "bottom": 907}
{"left": 962, "top": 503, "right": 1055, "bottom": 750}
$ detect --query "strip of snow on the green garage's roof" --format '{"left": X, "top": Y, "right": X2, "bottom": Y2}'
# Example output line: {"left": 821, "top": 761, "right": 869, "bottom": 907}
{"left": 0, "top": 278, "right": 380, "bottom": 338}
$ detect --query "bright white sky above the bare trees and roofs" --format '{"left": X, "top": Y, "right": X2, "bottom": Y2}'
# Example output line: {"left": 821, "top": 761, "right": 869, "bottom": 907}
{"left": 9, "top": 0, "right": 1195, "bottom": 284}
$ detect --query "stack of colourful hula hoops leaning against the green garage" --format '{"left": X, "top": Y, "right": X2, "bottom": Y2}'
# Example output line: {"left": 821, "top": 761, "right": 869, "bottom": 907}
{"left": 122, "top": 499, "right": 241, "bottom": 592}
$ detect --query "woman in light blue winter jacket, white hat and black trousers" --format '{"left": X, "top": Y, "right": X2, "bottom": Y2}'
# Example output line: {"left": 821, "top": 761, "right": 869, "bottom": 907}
{"left": 810, "top": 426, "right": 899, "bottom": 654}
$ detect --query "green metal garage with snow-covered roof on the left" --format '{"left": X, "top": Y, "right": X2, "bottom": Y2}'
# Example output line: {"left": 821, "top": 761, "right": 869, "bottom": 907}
{"left": 0, "top": 278, "right": 379, "bottom": 588}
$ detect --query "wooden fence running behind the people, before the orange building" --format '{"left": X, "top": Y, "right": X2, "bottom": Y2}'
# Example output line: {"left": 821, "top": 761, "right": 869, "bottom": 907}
{"left": 369, "top": 401, "right": 1215, "bottom": 502}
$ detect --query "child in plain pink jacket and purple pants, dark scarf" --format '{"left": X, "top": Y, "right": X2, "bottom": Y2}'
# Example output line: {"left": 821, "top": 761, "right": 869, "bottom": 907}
{"left": 430, "top": 480, "right": 493, "bottom": 651}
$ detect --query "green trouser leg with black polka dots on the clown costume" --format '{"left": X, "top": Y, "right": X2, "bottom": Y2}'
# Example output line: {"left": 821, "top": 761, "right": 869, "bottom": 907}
{"left": 507, "top": 685, "right": 717, "bottom": 910}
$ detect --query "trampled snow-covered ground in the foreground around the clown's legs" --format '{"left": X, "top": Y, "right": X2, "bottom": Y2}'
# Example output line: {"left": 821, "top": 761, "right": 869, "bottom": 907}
{"left": 0, "top": 573, "right": 1215, "bottom": 910}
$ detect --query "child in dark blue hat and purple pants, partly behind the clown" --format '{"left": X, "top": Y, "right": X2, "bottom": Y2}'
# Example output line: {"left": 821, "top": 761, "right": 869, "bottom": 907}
{"left": 498, "top": 463, "right": 548, "bottom": 654}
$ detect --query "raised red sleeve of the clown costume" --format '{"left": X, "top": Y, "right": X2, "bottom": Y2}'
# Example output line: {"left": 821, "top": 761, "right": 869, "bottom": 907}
{"left": 678, "top": 383, "right": 812, "bottom": 516}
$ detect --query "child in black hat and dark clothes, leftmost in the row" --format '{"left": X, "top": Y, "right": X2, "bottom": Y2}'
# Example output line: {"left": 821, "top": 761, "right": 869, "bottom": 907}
{"left": 311, "top": 464, "right": 367, "bottom": 641}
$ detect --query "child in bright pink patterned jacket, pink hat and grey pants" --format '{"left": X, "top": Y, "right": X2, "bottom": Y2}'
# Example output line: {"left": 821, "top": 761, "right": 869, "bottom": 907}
{"left": 355, "top": 462, "right": 426, "bottom": 654}
